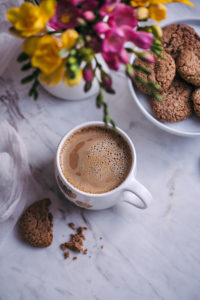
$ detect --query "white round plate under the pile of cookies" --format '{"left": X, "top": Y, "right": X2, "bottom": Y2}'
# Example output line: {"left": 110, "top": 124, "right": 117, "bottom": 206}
{"left": 129, "top": 19, "right": 200, "bottom": 136}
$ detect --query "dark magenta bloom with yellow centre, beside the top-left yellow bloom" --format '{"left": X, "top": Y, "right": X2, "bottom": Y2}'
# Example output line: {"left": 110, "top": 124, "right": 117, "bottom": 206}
{"left": 49, "top": 0, "right": 80, "bottom": 30}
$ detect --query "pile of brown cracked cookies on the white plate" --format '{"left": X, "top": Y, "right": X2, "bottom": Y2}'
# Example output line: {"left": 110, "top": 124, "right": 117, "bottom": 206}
{"left": 134, "top": 24, "right": 200, "bottom": 122}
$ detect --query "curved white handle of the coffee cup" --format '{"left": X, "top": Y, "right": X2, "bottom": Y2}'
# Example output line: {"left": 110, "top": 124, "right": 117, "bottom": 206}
{"left": 123, "top": 178, "right": 152, "bottom": 209}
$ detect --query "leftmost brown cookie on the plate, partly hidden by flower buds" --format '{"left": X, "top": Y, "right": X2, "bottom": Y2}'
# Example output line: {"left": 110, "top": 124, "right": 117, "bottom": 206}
{"left": 133, "top": 51, "right": 176, "bottom": 95}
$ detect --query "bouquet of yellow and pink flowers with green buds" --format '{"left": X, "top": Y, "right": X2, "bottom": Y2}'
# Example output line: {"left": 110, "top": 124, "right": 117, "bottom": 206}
{"left": 7, "top": 0, "right": 193, "bottom": 126}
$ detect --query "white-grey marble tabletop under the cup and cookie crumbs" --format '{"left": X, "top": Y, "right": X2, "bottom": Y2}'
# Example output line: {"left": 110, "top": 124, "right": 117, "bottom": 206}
{"left": 0, "top": 0, "right": 200, "bottom": 300}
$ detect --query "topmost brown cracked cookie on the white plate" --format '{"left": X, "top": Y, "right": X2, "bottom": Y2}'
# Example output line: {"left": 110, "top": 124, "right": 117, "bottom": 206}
{"left": 161, "top": 24, "right": 200, "bottom": 60}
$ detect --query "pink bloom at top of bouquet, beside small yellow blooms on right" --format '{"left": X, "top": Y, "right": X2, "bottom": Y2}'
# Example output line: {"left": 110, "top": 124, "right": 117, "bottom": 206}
{"left": 108, "top": 3, "right": 138, "bottom": 28}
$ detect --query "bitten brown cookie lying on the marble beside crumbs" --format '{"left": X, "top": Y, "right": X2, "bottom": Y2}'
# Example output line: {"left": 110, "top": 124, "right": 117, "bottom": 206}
{"left": 19, "top": 199, "right": 53, "bottom": 247}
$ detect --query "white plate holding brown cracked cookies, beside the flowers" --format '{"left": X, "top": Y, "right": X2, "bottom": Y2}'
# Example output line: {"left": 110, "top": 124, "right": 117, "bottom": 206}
{"left": 129, "top": 19, "right": 200, "bottom": 137}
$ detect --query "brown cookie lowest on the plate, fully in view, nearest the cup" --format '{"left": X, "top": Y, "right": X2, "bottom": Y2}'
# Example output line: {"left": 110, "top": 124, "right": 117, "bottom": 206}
{"left": 151, "top": 78, "right": 192, "bottom": 122}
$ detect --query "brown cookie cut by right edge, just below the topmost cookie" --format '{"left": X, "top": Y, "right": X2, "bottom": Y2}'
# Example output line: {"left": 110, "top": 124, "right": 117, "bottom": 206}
{"left": 176, "top": 48, "right": 200, "bottom": 86}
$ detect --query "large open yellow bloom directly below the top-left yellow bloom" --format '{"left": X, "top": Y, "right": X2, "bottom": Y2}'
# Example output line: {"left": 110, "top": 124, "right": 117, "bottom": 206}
{"left": 31, "top": 35, "right": 62, "bottom": 75}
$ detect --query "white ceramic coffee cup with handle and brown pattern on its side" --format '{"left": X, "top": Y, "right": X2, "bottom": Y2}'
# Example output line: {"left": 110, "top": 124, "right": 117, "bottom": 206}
{"left": 55, "top": 121, "right": 152, "bottom": 210}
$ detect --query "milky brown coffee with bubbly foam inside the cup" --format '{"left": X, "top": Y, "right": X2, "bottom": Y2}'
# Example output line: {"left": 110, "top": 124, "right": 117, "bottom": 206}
{"left": 59, "top": 125, "right": 132, "bottom": 194}
